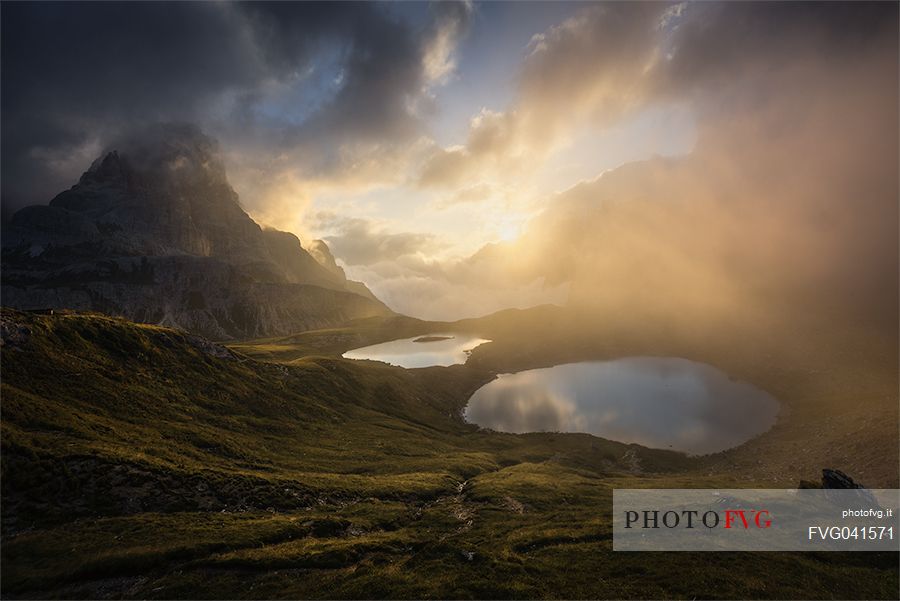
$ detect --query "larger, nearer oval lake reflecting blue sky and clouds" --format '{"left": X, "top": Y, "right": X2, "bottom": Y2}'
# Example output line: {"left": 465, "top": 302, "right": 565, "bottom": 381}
{"left": 464, "top": 357, "right": 779, "bottom": 455}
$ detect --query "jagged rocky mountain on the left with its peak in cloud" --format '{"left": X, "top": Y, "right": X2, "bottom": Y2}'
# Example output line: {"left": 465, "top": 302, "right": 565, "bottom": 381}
{"left": 2, "top": 125, "right": 390, "bottom": 339}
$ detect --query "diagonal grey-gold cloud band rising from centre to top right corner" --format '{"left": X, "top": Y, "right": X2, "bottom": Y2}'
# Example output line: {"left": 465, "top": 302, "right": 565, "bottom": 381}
{"left": 419, "top": 2, "right": 892, "bottom": 187}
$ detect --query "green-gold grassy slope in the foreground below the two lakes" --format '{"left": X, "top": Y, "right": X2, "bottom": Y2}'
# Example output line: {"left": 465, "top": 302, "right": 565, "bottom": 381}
{"left": 2, "top": 310, "right": 898, "bottom": 598}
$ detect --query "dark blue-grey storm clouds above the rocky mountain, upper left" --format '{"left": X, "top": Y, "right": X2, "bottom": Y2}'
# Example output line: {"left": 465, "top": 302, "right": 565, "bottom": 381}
{"left": 2, "top": 2, "right": 474, "bottom": 213}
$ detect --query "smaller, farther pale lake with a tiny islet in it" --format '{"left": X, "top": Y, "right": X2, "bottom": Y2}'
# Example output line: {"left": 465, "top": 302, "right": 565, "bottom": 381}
{"left": 342, "top": 334, "right": 490, "bottom": 368}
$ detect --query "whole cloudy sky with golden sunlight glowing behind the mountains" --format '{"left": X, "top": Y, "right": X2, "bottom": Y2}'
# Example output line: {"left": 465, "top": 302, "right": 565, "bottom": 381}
{"left": 0, "top": 2, "right": 897, "bottom": 319}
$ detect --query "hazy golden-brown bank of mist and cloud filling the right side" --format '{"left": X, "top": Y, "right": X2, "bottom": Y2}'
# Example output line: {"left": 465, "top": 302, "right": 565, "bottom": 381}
{"left": 460, "top": 4, "right": 898, "bottom": 333}
